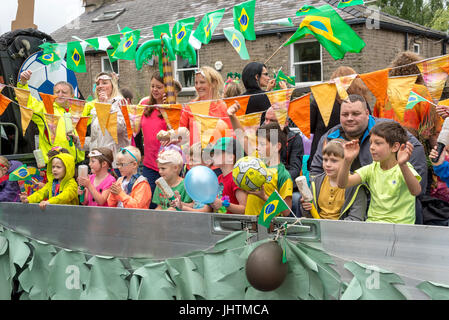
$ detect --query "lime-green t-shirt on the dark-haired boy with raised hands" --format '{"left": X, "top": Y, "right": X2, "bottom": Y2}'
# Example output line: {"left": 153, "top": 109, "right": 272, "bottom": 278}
{"left": 355, "top": 162, "right": 421, "bottom": 224}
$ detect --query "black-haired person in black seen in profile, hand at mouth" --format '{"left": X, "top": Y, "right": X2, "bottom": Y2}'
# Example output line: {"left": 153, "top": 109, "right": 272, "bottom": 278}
{"left": 242, "top": 62, "right": 276, "bottom": 124}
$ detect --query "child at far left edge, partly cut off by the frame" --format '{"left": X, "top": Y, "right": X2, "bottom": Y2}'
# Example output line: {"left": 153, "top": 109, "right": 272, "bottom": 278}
{"left": 0, "top": 156, "right": 22, "bottom": 202}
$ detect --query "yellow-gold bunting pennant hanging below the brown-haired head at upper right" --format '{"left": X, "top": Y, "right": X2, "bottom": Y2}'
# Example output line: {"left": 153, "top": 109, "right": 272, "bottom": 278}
{"left": 387, "top": 76, "right": 418, "bottom": 122}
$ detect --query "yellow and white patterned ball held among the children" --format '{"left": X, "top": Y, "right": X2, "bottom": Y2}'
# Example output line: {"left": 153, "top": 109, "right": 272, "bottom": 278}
{"left": 232, "top": 157, "right": 268, "bottom": 191}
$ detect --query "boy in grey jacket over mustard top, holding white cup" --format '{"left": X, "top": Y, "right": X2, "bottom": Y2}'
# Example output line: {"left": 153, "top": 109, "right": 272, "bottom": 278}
{"left": 301, "top": 139, "right": 367, "bottom": 221}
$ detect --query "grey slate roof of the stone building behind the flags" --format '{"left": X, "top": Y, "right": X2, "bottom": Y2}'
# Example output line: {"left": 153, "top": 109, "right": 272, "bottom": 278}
{"left": 51, "top": 0, "right": 446, "bottom": 43}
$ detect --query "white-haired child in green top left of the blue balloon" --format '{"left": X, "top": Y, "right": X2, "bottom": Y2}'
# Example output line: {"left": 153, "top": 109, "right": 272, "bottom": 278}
{"left": 153, "top": 149, "right": 192, "bottom": 211}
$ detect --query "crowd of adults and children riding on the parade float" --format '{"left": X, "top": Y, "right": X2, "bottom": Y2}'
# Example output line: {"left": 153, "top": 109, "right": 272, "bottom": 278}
{"left": 0, "top": 52, "right": 449, "bottom": 225}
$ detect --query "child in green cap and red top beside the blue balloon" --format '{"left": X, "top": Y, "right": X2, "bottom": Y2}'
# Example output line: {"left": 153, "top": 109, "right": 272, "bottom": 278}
{"left": 211, "top": 137, "right": 248, "bottom": 214}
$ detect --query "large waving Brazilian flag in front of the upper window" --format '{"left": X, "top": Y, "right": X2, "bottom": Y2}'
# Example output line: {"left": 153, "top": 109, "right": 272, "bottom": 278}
{"left": 284, "top": 5, "right": 365, "bottom": 60}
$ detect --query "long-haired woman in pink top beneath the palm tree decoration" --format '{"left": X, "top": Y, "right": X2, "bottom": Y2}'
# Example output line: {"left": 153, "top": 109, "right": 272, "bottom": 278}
{"left": 139, "top": 72, "right": 167, "bottom": 209}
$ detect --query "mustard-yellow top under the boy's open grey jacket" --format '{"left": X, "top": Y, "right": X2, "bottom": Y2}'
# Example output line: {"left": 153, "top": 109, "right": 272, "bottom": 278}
{"left": 318, "top": 176, "right": 345, "bottom": 220}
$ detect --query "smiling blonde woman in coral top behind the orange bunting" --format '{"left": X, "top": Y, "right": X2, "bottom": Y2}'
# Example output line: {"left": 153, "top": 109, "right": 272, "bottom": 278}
{"left": 179, "top": 67, "right": 232, "bottom": 145}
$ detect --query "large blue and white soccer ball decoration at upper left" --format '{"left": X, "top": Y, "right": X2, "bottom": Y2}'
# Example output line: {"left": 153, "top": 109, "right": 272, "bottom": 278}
{"left": 17, "top": 51, "right": 78, "bottom": 101}
